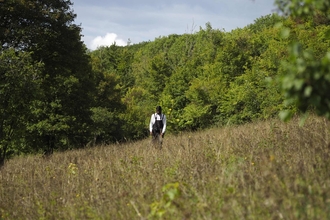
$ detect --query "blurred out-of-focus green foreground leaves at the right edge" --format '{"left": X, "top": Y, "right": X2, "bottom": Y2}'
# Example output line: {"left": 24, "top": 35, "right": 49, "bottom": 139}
{"left": 275, "top": 0, "right": 330, "bottom": 120}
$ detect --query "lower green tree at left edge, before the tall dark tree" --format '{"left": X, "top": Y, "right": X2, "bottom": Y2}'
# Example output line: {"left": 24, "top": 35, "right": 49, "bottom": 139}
{"left": 0, "top": 49, "right": 42, "bottom": 165}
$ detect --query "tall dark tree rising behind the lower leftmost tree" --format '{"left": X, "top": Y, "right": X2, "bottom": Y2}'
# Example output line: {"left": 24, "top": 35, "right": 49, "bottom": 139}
{"left": 0, "top": 0, "right": 94, "bottom": 155}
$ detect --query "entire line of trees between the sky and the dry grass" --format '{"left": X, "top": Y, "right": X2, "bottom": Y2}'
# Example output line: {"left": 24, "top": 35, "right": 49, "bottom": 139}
{"left": 0, "top": 0, "right": 330, "bottom": 164}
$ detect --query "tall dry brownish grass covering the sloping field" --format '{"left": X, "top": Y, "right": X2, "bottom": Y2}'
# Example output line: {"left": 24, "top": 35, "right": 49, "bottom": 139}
{"left": 0, "top": 117, "right": 330, "bottom": 219}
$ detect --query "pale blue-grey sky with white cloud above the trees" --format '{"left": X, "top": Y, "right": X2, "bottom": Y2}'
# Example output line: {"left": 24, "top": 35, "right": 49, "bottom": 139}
{"left": 71, "top": 0, "right": 276, "bottom": 50}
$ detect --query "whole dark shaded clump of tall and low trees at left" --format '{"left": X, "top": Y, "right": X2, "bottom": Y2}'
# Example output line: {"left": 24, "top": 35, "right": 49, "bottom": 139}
{"left": 0, "top": 0, "right": 95, "bottom": 160}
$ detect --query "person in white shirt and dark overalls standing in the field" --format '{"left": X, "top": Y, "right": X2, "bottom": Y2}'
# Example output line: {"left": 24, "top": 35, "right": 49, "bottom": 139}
{"left": 149, "top": 106, "right": 166, "bottom": 146}
